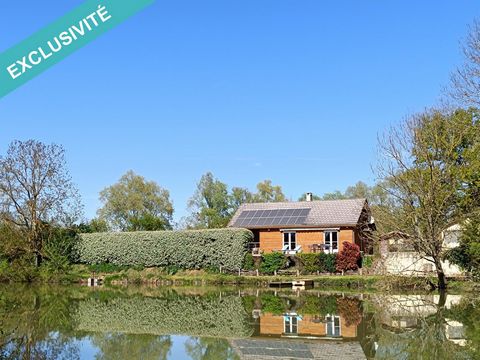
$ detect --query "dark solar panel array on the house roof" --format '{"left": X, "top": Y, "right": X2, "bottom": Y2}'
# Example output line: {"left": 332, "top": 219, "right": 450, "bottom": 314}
{"left": 233, "top": 209, "right": 310, "bottom": 228}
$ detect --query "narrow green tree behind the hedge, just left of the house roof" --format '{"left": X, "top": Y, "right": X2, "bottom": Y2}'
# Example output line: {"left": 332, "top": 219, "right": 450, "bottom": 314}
{"left": 188, "top": 172, "right": 231, "bottom": 229}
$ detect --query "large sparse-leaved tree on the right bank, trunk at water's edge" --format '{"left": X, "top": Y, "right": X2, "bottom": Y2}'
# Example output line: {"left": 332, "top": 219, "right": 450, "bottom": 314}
{"left": 378, "top": 110, "right": 480, "bottom": 289}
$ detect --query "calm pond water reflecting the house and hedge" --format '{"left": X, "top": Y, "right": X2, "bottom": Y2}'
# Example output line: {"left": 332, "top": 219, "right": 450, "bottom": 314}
{"left": 0, "top": 285, "right": 480, "bottom": 360}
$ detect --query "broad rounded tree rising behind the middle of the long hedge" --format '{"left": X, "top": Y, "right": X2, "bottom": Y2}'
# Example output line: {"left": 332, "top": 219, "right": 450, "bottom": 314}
{"left": 98, "top": 171, "right": 173, "bottom": 231}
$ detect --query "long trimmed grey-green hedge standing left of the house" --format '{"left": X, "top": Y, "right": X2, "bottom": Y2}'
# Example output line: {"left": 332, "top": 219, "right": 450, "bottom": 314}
{"left": 77, "top": 229, "right": 253, "bottom": 270}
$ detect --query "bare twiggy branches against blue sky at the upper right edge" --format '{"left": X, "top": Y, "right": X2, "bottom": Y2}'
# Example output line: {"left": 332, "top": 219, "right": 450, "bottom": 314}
{"left": 451, "top": 20, "right": 480, "bottom": 107}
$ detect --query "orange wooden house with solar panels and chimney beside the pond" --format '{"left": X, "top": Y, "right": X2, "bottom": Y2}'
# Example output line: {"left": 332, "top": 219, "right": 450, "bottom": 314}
{"left": 228, "top": 197, "right": 375, "bottom": 255}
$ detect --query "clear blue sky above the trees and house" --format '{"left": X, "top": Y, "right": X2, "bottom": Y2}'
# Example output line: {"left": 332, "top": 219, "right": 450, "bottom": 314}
{"left": 0, "top": 0, "right": 480, "bottom": 224}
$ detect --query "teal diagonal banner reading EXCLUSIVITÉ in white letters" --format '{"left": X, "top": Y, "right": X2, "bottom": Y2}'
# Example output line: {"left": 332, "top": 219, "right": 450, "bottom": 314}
{"left": 0, "top": 0, "right": 154, "bottom": 98}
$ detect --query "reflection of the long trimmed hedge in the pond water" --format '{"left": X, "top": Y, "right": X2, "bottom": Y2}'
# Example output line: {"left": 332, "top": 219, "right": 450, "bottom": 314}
{"left": 74, "top": 295, "right": 254, "bottom": 338}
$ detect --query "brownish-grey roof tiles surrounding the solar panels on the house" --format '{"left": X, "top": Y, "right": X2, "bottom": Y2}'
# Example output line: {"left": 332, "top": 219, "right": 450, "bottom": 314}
{"left": 228, "top": 199, "right": 367, "bottom": 228}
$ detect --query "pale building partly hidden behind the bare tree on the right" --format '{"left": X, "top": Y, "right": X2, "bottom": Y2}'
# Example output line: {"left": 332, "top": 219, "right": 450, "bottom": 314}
{"left": 379, "top": 225, "right": 464, "bottom": 277}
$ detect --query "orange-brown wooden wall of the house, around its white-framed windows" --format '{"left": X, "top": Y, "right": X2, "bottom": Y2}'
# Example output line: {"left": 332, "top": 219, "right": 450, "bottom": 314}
{"left": 258, "top": 228, "right": 355, "bottom": 253}
